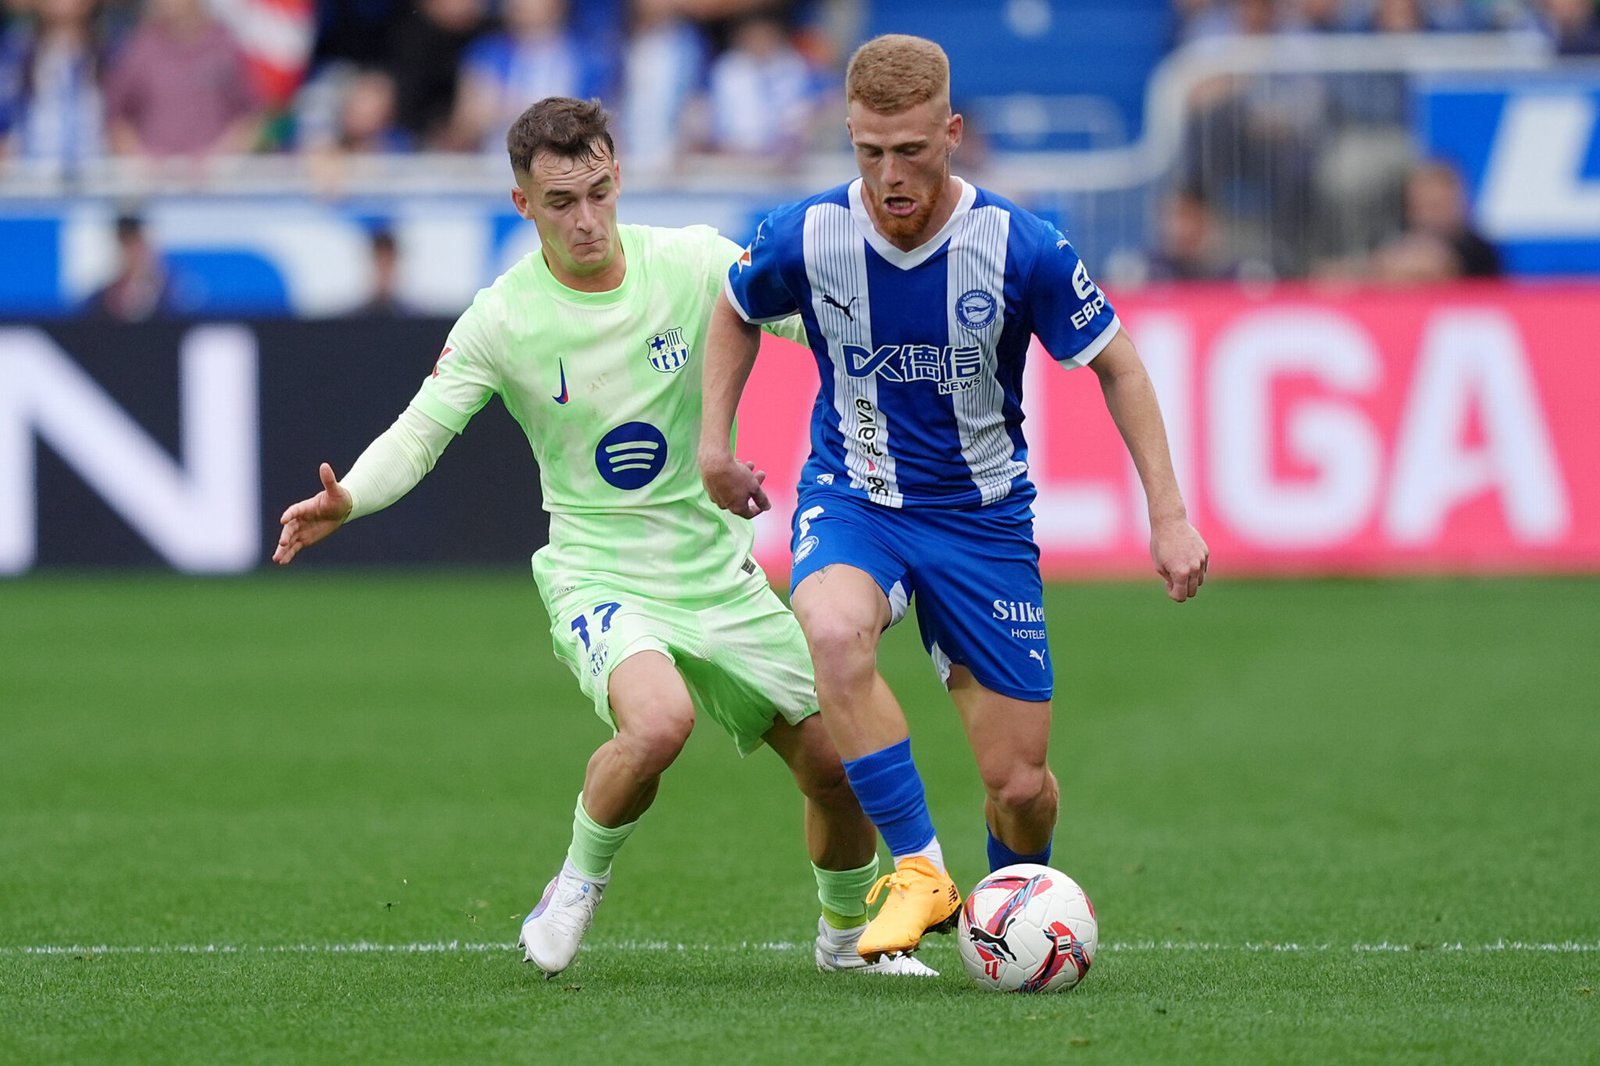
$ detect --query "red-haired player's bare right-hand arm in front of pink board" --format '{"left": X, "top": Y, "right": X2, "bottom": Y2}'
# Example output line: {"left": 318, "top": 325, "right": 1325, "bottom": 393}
{"left": 1090, "top": 331, "right": 1211, "bottom": 603}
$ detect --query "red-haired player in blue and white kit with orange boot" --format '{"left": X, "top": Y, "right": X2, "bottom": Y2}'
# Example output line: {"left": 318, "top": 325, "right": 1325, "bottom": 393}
{"left": 699, "top": 35, "right": 1208, "bottom": 959}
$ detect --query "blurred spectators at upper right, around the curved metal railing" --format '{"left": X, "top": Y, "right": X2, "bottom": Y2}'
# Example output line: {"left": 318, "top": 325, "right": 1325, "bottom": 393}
{"left": 1142, "top": 0, "right": 1600, "bottom": 282}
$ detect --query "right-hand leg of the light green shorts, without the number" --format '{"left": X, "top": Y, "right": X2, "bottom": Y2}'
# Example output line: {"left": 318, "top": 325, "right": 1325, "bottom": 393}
{"left": 694, "top": 584, "right": 818, "bottom": 754}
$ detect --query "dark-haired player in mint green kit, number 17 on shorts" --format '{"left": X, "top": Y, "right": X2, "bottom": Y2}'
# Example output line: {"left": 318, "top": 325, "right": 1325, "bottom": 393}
{"left": 274, "top": 98, "right": 933, "bottom": 975}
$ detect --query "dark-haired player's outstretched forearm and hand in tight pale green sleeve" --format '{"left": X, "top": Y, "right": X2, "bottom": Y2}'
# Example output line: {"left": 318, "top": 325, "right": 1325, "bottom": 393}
{"left": 272, "top": 407, "right": 454, "bottom": 567}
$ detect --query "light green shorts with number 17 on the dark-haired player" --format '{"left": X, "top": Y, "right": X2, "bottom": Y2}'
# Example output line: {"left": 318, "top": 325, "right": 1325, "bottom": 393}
{"left": 539, "top": 570, "right": 816, "bottom": 755}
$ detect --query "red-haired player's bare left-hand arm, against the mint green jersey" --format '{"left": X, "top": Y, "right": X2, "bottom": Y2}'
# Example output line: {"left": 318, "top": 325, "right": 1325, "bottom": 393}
{"left": 699, "top": 295, "right": 773, "bottom": 519}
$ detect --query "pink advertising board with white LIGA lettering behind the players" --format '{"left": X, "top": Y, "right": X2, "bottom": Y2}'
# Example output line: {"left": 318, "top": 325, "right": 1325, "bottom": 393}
{"left": 739, "top": 283, "right": 1600, "bottom": 579}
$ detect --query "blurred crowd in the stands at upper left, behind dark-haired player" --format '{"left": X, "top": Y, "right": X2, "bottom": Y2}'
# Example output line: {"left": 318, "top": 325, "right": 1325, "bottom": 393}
{"left": 0, "top": 0, "right": 840, "bottom": 176}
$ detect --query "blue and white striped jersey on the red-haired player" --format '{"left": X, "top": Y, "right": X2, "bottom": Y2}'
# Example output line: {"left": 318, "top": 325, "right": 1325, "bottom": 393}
{"left": 726, "top": 179, "right": 1120, "bottom": 507}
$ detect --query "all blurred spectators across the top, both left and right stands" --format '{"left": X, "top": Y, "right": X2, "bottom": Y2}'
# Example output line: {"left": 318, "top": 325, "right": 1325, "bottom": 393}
{"left": 9, "top": 0, "right": 1600, "bottom": 317}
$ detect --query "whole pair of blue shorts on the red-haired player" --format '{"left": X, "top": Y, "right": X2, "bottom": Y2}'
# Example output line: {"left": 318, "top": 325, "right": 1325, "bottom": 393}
{"left": 789, "top": 488, "right": 1054, "bottom": 701}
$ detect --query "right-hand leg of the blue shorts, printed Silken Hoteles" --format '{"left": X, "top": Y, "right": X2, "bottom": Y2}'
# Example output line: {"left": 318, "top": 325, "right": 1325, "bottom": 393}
{"left": 914, "top": 514, "right": 1054, "bottom": 703}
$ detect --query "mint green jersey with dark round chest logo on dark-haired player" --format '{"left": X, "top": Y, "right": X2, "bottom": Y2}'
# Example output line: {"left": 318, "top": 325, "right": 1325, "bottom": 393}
{"left": 413, "top": 226, "right": 798, "bottom": 603}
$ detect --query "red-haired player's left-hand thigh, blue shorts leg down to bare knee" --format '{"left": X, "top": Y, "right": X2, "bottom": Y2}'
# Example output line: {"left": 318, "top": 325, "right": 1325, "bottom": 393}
{"left": 789, "top": 493, "right": 912, "bottom": 635}
